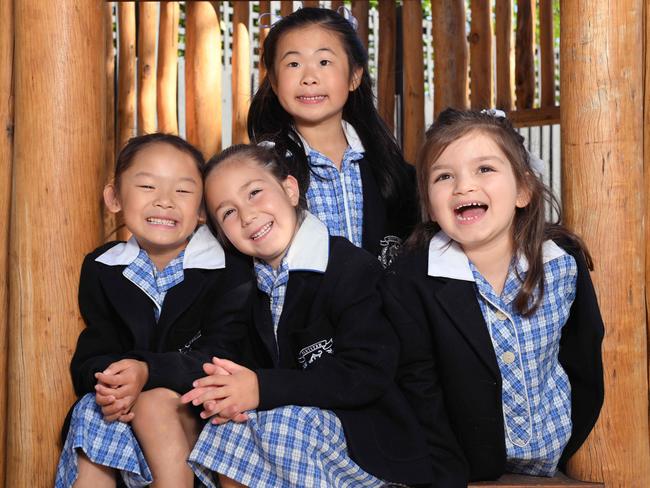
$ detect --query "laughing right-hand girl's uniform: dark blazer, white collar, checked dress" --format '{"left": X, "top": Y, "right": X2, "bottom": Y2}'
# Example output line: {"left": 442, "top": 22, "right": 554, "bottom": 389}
{"left": 381, "top": 232, "right": 603, "bottom": 481}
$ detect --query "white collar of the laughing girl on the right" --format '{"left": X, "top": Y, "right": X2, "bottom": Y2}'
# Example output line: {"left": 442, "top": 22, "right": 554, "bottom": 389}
{"left": 427, "top": 231, "right": 566, "bottom": 281}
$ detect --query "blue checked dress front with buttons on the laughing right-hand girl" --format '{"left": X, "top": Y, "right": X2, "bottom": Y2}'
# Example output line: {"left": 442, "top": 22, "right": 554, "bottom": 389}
{"left": 470, "top": 253, "right": 578, "bottom": 476}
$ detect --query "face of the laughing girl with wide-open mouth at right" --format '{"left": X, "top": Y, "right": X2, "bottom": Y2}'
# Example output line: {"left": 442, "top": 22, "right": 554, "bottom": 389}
{"left": 429, "top": 132, "right": 530, "bottom": 258}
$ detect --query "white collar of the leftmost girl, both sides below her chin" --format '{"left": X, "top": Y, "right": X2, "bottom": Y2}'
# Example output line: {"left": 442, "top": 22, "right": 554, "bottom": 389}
{"left": 95, "top": 225, "right": 226, "bottom": 269}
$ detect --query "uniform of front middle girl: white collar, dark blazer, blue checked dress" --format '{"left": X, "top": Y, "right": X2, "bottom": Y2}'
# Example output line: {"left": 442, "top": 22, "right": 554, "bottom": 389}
{"left": 190, "top": 213, "right": 431, "bottom": 487}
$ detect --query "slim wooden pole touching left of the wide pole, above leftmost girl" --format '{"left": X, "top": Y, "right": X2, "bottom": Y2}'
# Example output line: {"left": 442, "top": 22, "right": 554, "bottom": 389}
{"left": 157, "top": 2, "right": 180, "bottom": 134}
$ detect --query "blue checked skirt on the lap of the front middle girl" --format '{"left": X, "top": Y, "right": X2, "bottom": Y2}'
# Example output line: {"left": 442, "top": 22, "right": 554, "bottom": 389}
{"left": 188, "top": 406, "right": 383, "bottom": 488}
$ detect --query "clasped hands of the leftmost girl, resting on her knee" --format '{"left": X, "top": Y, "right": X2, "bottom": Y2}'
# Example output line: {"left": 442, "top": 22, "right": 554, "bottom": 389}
{"left": 95, "top": 359, "right": 149, "bottom": 422}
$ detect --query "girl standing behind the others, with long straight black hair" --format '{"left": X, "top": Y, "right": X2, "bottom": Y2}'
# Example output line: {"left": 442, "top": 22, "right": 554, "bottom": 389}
{"left": 248, "top": 8, "right": 417, "bottom": 265}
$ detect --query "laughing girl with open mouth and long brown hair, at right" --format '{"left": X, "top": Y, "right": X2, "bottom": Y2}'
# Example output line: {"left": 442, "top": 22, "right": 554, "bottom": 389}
{"left": 382, "top": 109, "right": 603, "bottom": 480}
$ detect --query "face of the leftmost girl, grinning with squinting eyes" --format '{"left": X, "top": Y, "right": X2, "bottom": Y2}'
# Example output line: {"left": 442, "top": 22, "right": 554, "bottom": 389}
{"left": 104, "top": 143, "right": 203, "bottom": 268}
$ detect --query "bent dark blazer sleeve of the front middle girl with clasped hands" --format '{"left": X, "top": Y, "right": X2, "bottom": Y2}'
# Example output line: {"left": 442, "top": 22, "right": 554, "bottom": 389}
{"left": 256, "top": 253, "right": 398, "bottom": 410}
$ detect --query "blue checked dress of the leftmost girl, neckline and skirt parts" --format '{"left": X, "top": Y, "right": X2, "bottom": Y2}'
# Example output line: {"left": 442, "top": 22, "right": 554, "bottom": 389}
{"left": 55, "top": 249, "right": 185, "bottom": 488}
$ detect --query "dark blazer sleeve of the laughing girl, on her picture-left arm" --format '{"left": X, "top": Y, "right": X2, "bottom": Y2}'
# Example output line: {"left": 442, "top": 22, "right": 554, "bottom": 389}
{"left": 380, "top": 270, "right": 469, "bottom": 488}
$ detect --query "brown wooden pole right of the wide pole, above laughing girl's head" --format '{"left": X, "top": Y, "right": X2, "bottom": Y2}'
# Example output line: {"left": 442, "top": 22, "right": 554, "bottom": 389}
{"left": 469, "top": 0, "right": 492, "bottom": 109}
